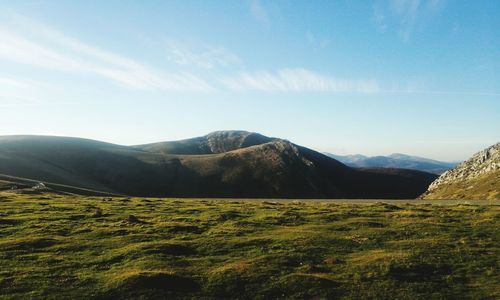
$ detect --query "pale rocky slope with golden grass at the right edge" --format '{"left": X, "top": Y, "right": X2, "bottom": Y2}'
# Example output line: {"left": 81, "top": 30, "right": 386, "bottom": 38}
{"left": 422, "top": 143, "right": 500, "bottom": 200}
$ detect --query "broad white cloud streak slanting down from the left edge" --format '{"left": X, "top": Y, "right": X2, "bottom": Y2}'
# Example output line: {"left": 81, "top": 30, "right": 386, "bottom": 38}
{"left": 0, "top": 16, "right": 211, "bottom": 91}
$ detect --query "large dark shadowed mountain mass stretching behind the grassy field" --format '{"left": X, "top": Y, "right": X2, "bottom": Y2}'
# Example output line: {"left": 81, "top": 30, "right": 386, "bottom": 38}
{"left": 0, "top": 131, "right": 437, "bottom": 198}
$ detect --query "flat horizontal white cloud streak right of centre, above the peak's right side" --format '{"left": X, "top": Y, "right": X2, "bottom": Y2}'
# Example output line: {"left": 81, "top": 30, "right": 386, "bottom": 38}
{"left": 220, "top": 69, "right": 380, "bottom": 93}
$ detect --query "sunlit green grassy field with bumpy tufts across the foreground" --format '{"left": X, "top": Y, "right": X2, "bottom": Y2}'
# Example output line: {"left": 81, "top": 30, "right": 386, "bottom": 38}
{"left": 0, "top": 193, "right": 500, "bottom": 299}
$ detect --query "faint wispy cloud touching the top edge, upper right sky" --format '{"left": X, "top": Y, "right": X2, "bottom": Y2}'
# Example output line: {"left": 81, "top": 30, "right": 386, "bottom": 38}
{"left": 372, "top": 0, "right": 445, "bottom": 41}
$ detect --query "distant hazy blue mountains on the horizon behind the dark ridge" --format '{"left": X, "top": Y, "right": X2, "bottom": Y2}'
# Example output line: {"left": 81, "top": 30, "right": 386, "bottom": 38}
{"left": 325, "top": 153, "right": 457, "bottom": 174}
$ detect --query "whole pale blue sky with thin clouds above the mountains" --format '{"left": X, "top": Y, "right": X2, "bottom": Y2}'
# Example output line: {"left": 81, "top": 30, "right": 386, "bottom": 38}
{"left": 0, "top": 0, "right": 500, "bottom": 161}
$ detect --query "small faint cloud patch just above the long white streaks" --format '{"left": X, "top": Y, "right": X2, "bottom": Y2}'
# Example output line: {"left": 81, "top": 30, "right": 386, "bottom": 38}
{"left": 166, "top": 42, "right": 241, "bottom": 69}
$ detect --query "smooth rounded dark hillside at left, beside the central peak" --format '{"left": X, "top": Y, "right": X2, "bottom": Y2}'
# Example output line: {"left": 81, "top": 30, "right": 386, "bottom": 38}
{"left": 0, "top": 136, "right": 171, "bottom": 195}
